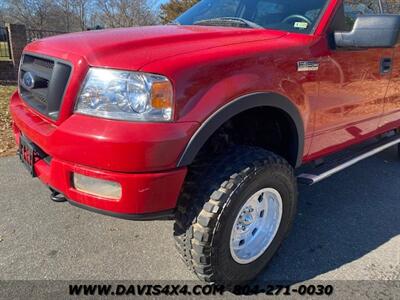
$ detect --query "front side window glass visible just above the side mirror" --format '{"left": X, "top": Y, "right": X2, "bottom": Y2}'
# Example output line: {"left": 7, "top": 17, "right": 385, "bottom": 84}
{"left": 343, "top": 0, "right": 382, "bottom": 30}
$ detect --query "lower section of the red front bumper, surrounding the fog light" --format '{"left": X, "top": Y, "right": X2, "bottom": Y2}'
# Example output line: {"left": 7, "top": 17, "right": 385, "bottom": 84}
{"left": 35, "top": 154, "right": 186, "bottom": 219}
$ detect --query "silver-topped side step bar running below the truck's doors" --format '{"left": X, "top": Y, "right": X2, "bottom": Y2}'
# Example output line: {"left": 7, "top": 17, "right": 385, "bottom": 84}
{"left": 297, "top": 134, "right": 400, "bottom": 185}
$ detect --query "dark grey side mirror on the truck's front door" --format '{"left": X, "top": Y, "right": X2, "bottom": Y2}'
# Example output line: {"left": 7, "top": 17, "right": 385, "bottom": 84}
{"left": 334, "top": 15, "right": 400, "bottom": 48}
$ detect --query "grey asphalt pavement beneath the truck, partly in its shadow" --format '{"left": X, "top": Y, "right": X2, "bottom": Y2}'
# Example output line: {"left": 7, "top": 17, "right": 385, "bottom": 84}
{"left": 0, "top": 148, "right": 400, "bottom": 292}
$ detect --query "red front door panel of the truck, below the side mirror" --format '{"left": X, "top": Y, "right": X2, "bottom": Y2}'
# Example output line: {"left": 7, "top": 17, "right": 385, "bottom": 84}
{"left": 310, "top": 49, "right": 393, "bottom": 156}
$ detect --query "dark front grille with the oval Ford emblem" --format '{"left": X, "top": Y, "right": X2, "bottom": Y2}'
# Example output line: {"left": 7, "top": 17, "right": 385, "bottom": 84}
{"left": 19, "top": 54, "right": 71, "bottom": 120}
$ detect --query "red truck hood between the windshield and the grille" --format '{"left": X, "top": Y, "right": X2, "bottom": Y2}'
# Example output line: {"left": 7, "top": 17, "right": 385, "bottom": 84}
{"left": 25, "top": 25, "right": 287, "bottom": 70}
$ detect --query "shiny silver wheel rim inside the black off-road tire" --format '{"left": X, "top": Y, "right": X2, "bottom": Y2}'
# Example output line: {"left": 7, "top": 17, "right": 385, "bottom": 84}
{"left": 230, "top": 188, "right": 282, "bottom": 264}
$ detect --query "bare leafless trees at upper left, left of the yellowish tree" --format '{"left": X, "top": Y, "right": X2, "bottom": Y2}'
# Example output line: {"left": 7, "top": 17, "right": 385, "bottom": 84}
{"left": 0, "top": 0, "right": 158, "bottom": 32}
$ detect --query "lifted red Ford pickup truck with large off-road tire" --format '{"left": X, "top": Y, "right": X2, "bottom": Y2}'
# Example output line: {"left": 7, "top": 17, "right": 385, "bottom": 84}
{"left": 10, "top": 0, "right": 400, "bottom": 283}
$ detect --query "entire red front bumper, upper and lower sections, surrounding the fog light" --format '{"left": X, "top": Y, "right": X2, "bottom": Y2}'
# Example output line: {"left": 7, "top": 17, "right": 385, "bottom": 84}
{"left": 10, "top": 93, "right": 197, "bottom": 219}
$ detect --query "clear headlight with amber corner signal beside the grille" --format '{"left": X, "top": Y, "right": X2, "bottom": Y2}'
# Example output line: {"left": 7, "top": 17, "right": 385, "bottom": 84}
{"left": 75, "top": 68, "right": 173, "bottom": 122}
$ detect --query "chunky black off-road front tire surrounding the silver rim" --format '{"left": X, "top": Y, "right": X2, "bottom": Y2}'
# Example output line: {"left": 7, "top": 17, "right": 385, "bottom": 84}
{"left": 174, "top": 146, "right": 298, "bottom": 285}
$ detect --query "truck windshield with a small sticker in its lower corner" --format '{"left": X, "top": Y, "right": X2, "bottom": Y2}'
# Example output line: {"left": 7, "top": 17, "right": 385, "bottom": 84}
{"left": 175, "top": 0, "right": 328, "bottom": 33}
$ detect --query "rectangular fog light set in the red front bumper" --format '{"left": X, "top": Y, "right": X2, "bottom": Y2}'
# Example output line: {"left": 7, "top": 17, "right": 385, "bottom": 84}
{"left": 73, "top": 173, "right": 122, "bottom": 199}
